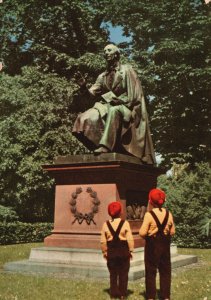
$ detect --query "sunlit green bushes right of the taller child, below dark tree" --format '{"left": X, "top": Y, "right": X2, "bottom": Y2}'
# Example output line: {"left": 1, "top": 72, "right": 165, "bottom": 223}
{"left": 158, "top": 163, "right": 211, "bottom": 248}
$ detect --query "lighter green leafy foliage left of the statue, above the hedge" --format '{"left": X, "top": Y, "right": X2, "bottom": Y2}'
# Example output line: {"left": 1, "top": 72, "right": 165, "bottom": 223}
{"left": 0, "top": 68, "right": 85, "bottom": 221}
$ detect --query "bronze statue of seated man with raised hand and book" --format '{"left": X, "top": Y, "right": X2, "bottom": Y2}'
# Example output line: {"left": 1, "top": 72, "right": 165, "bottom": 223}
{"left": 73, "top": 44, "right": 155, "bottom": 164}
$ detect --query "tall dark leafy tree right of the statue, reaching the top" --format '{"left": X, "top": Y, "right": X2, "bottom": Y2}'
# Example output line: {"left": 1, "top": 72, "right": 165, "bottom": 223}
{"left": 91, "top": 0, "right": 211, "bottom": 165}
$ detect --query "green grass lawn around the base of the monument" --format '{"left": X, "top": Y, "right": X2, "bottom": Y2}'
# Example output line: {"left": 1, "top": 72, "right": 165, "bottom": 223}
{"left": 0, "top": 243, "right": 211, "bottom": 300}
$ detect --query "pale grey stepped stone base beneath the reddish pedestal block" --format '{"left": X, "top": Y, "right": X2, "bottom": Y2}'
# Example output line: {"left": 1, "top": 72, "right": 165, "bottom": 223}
{"left": 4, "top": 245, "right": 197, "bottom": 281}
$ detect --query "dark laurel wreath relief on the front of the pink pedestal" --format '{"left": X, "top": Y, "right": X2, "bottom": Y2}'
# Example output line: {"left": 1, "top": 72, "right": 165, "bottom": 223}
{"left": 69, "top": 187, "right": 100, "bottom": 225}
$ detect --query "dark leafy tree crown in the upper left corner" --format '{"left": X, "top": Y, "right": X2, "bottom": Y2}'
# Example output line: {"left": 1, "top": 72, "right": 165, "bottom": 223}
{"left": 0, "top": 0, "right": 107, "bottom": 77}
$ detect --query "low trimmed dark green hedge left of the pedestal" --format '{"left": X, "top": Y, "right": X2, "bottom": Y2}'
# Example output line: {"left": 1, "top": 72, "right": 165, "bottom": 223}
{"left": 0, "top": 222, "right": 53, "bottom": 245}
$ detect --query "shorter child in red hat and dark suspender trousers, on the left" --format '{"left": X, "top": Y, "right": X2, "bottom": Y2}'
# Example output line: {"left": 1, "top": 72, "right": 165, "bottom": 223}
{"left": 101, "top": 202, "right": 134, "bottom": 299}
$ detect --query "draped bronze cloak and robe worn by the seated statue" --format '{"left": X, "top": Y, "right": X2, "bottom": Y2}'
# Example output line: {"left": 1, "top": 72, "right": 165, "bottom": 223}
{"left": 73, "top": 64, "right": 156, "bottom": 164}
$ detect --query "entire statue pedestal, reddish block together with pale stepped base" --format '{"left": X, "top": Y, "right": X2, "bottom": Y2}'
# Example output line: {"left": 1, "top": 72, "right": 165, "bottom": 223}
{"left": 4, "top": 153, "right": 197, "bottom": 280}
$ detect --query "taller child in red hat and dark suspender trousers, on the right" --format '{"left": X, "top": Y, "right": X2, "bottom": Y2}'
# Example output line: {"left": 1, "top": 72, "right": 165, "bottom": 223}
{"left": 139, "top": 189, "right": 175, "bottom": 300}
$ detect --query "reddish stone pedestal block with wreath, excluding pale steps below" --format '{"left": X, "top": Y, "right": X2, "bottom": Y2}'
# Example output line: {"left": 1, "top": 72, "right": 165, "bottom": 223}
{"left": 43, "top": 153, "right": 165, "bottom": 249}
